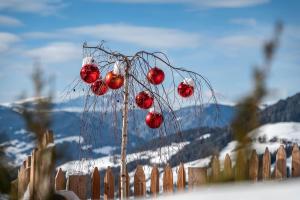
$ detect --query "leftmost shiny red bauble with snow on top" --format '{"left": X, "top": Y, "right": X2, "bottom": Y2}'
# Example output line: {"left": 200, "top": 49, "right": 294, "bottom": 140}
{"left": 80, "top": 64, "right": 100, "bottom": 84}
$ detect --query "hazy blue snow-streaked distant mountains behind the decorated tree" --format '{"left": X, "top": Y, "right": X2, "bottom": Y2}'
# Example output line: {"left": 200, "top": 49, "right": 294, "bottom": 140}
{"left": 0, "top": 97, "right": 234, "bottom": 165}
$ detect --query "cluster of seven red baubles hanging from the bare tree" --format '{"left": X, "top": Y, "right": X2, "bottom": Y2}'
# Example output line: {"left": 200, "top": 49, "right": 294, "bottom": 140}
{"left": 80, "top": 59, "right": 194, "bottom": 128}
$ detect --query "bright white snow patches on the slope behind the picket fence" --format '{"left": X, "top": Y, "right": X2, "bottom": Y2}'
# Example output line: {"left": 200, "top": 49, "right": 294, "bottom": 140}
{"left": 60, "top": 122, "right": 300, "bottom": 188}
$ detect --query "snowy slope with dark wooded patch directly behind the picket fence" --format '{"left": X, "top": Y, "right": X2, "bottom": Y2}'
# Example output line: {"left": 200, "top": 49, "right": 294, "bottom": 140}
{"left": 59, "top": 122, "right": 300, "bottom": 188}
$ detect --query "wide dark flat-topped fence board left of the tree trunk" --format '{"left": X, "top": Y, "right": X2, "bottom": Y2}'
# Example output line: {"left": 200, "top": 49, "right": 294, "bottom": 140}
{"left": 67, "top": 175, "right": 88, "bottom": 199}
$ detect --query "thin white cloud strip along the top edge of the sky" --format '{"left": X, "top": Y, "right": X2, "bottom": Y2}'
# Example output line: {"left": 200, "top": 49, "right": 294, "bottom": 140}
{"left": 97, "top": 0, "right": 270, "bottom": 8}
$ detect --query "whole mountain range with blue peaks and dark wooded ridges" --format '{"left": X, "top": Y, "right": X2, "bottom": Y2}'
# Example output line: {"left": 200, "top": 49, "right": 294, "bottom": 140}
{"left": 0, "top": 93, "right": 300, "bottom": 173}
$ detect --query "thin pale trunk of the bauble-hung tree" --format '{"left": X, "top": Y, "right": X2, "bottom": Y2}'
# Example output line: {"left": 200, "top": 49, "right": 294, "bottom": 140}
{"left": 120, "top": 59, "right": 130, "bottom": 200}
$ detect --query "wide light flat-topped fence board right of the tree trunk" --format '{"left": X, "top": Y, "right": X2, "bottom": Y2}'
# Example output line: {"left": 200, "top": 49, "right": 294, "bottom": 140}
{"left": 188, "top": 167, "right": 207, "bottom": 190}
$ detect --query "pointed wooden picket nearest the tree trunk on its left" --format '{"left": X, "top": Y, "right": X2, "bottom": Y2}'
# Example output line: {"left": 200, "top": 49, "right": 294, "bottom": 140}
{"left": 104, "top": 167, "right": 115, "bottom": 200}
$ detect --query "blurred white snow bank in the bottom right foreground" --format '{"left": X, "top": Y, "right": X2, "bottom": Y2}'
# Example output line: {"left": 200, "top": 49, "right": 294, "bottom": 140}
{"left": 158, "top": 180, "right": 300, "bottom": 200}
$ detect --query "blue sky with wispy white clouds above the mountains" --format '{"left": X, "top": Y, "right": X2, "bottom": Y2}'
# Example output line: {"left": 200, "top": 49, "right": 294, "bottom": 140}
{"left": 0, "top": 0, "right": 300, "bottom": 103}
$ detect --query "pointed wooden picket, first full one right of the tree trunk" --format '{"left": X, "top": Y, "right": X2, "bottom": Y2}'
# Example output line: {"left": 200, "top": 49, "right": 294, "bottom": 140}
{"left": 134, "top": 165, "right": 146, "bottom": 197}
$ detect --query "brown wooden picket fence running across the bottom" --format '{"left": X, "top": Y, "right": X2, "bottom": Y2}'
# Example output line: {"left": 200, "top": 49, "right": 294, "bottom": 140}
{"left": 13, "top": 132, "right": 300, "bottom": 199}
